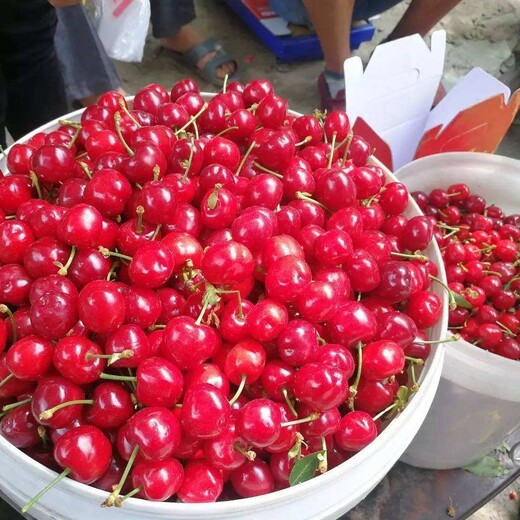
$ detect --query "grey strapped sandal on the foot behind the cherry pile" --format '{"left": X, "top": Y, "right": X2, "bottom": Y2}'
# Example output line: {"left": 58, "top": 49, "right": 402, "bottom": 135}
{"left": 160, "top": 38, "right": 239, "bottom": 87}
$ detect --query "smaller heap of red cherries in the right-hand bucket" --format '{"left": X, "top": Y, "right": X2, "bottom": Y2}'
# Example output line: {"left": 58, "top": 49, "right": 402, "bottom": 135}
{"left": 412, "top": 184, "right": 520, "bottom": 360}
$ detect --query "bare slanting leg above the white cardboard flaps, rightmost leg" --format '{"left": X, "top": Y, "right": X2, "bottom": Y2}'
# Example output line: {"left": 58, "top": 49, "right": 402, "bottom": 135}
{"left": 388, "top": 0, "right": 460, "bottom": 40}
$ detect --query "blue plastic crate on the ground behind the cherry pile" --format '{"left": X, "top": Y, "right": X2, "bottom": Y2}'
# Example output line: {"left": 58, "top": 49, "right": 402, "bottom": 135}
{"left": 222, "top": 0, "right": 375, "bottom": 62}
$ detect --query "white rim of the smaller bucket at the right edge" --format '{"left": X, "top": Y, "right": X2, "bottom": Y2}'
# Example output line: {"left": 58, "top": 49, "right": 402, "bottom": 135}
{"left": 395, "top": 152, "right": 520, "bottom": 402}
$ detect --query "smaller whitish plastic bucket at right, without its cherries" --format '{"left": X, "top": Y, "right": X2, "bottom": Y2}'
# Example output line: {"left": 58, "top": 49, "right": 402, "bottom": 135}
{"left": 396, "top": 152, "right": 520, "bottom": 469}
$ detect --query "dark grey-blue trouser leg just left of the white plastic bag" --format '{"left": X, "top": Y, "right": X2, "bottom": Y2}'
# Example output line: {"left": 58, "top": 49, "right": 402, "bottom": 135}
{"left": 54, "top": 4, "right": 125, "bottom": 106}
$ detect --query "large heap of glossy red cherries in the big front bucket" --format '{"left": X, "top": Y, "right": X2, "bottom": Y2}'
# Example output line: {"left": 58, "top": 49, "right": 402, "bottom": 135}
{"left": 0, "top": 79, "right": 442, "bottom": 511}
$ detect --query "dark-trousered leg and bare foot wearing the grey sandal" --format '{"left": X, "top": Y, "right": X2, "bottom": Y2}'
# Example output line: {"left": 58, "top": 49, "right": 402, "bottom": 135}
{"left": 150, "top": 0, "right": 236, "bottom": 80}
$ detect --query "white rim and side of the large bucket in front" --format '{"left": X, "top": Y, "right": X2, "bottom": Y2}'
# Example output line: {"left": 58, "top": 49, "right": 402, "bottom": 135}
{"left": 0, "top": 98, "right": 448, "bottom": 520}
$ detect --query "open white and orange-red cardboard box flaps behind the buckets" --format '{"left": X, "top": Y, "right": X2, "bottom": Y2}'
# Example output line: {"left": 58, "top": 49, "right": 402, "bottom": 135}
{"left": 344, "top": 31, "right": 520, "bottom": 169}
